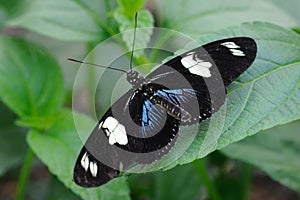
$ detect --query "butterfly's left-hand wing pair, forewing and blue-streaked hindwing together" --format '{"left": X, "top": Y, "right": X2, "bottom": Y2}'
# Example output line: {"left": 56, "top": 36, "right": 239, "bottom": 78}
{"left": 73, "top": 90, "right": 180, "bottom": 187}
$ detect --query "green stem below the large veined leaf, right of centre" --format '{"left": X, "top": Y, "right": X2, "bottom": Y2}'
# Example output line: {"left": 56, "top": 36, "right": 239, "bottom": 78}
{"left": 194, "top": 160, "right": 221, "bottom": 200}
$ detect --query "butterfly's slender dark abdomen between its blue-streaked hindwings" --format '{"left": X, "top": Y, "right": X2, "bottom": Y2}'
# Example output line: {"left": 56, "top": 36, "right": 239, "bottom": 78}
{"left": 150, "top": 95, "right": 192, "bottom": 122}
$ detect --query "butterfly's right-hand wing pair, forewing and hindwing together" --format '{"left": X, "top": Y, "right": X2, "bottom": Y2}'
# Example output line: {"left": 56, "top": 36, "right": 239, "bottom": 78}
{"left": 147, "top": 37, "right": 257, "bottom": 125}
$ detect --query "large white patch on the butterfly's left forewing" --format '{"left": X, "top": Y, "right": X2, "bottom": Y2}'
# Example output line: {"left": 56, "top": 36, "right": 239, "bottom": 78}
{"left": 102, "top": 116, "right": 128, "bottom": 145}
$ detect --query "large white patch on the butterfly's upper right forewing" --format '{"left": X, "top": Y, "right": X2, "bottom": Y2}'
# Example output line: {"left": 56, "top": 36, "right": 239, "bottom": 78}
{"left": 181, "top": 52, "right": 212, "bottom": 77}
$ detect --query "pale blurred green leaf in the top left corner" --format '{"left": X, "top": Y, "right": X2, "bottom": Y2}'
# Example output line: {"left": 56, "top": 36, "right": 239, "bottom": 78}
{"left": 8, "top": 0, "right": 106, "bottom": 41}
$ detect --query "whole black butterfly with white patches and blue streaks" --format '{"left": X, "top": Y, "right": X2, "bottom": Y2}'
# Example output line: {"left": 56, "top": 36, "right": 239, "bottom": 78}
{"left": 73, "top": 37, "right": 257, "bottom": 187}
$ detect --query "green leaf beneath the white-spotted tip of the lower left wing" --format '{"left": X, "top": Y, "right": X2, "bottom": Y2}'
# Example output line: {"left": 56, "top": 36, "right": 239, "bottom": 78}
{"left": 27, "top": 110, "right": 129, "bottom": 199}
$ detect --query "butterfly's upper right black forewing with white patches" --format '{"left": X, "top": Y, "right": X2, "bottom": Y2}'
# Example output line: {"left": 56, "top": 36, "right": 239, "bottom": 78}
{"left": 147, "top": 37, "right": 257, "bottom": 88}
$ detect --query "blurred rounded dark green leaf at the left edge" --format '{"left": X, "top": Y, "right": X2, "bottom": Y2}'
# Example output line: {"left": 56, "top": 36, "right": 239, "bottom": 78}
{"left": 0, "top": 37, "right": 64, "bottom": 128}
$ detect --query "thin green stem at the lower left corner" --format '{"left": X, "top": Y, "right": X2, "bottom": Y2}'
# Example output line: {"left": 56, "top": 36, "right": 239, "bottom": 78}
{"left": 16, "top": 148, "right": 34, "bottom": 200}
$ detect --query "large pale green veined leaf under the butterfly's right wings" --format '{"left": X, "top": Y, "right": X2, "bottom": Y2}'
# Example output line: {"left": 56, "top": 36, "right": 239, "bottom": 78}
{"left": 140, "top": 22, "right": 300, "bottom": 170}
